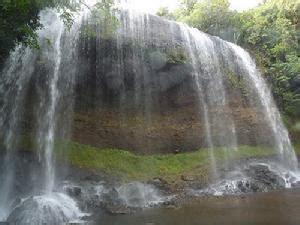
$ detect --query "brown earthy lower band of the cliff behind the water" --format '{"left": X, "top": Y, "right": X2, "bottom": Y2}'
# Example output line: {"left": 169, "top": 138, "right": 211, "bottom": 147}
{"left": 72, "top": 78, "right": 272, "bottom": 154}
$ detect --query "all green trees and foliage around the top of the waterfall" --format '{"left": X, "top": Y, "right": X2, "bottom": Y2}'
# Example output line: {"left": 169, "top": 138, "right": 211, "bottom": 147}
{"left": 0, "top": 0, "right": 300, "bottom": 118}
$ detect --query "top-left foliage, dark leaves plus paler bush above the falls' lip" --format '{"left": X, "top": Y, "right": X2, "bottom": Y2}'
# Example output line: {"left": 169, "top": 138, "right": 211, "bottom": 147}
{"left": 0, "top": 0, "right": 117, "bottom": 68}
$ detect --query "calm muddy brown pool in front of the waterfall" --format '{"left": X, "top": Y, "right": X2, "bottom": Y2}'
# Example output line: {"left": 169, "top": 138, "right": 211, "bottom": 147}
{"left": 96, "top": 189, "right": 300, "bottom": 225}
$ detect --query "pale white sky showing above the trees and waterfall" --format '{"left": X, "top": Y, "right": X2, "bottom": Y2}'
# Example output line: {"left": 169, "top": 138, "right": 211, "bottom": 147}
{"left": 86, "top": 0, "right": 262, "bottom": 13}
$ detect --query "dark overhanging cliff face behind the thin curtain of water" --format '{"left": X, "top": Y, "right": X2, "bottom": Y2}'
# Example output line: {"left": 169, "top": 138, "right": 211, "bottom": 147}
{"left": 14, "top": 12, "right": 272, "bottom": 154}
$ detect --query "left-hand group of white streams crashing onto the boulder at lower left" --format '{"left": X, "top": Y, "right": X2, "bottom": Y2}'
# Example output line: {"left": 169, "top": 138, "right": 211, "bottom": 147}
{"left": 0, "top": 10, "right": 79, "bottom": 224}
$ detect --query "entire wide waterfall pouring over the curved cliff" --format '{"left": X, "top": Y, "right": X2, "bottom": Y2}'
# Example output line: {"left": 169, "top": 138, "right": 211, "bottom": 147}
{"left": 0, "top": 2, "right": 298, "bottom": 223}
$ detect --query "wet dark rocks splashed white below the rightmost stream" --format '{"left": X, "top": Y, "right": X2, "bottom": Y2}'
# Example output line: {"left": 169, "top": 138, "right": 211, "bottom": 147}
{"left": 200, "top": 161, "right": 299, "bottom": 196}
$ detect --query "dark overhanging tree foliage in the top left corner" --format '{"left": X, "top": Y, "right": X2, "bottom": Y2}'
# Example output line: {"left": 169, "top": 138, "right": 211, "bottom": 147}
{"left": 0, "top": 0, "right": 77, "bottom": 66}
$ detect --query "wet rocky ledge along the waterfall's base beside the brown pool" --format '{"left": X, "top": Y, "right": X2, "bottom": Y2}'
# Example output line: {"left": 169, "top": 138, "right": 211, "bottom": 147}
{"left": 53, "top": 159, "right": 299, "bottom": 218}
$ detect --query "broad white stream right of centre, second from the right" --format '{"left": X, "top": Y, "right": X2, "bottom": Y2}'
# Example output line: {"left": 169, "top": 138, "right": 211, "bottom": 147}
{"left": 179, "top": 24, "right": 237, "bottom": 179}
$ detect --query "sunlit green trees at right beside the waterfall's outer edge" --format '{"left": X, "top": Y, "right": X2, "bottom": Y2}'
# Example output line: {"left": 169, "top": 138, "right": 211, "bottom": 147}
{"left": 239, "top": 0, "right": 300, "bottom": 117}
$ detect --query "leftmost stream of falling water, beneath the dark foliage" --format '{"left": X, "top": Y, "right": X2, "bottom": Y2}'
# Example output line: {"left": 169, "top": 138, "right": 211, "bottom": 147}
{"left": 0, "top": 46, "right": 35, "bottom": 220}
